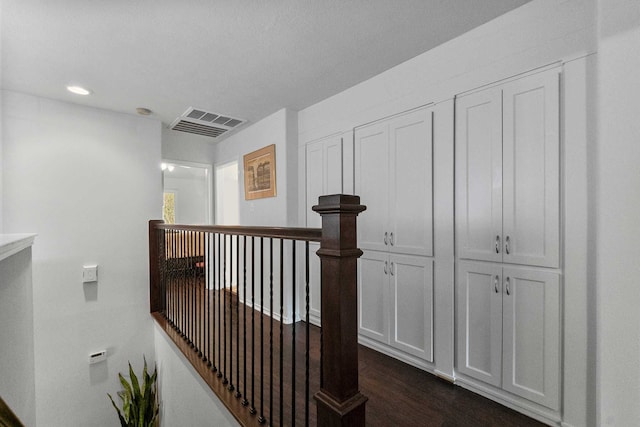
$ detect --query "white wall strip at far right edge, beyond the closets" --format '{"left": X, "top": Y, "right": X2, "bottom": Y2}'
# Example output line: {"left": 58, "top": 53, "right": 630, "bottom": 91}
{"left": 591, "top": 0, "right": 640, "bottom": 426}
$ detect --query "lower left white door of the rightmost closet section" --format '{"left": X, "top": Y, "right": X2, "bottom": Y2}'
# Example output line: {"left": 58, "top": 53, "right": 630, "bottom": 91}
{"left": 456, "top": 261, "right": 502, "bottom": 387}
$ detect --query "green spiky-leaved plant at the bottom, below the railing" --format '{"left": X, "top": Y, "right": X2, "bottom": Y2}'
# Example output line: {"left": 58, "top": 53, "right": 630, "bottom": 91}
{"left": 107, "top": 359, "right": 160, "bottom": 427}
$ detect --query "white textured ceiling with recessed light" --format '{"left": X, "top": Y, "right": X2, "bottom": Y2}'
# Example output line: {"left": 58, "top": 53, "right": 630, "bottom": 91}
{"left": 0, "top": 0, "right": 529, "bottom": 140}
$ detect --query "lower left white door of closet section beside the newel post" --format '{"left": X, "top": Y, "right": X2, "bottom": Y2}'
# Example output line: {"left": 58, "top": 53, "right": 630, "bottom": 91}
{"left": 358, "top": 251, "right": 389, "bottom": 344}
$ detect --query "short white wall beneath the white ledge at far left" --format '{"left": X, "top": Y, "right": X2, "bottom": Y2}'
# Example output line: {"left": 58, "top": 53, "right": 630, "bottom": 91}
{"left": 0, "top": 248, "right": 36, "bottom": 426}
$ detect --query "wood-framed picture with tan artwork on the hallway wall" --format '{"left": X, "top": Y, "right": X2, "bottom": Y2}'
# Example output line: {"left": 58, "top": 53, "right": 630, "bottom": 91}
{"left": 244, "top": 144, "right": 276, "bottom": 200}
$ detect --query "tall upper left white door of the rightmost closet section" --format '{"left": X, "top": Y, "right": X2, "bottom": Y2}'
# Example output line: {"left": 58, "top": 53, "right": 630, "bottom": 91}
{"left": 456, "top": 88, "right": 502, "bottom": 262}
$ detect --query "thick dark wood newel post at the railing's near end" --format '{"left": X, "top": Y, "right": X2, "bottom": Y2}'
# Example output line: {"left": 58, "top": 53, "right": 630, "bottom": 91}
{"left": 313, "top": 194, "right": 367, "bottom": 427}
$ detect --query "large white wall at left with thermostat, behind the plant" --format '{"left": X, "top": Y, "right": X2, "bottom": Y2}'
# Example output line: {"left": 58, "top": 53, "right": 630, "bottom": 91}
{"left": 3, "top": 92, "right": 162, "bottom": 426}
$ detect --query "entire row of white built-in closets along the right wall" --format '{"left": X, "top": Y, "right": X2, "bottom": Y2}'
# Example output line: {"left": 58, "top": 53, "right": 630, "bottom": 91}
{"left": 304, "top": 67, "right": 563, "bottom": 421}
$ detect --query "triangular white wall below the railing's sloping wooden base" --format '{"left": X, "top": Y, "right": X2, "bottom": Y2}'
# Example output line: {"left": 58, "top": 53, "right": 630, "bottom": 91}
{"left": 154, "top": 326, "right": 239, "bottom": 427}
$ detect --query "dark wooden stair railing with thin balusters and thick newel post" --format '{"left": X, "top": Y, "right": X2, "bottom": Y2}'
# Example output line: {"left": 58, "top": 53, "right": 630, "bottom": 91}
{"left": 149, "top": 195, "right": 367, "bottom": 427}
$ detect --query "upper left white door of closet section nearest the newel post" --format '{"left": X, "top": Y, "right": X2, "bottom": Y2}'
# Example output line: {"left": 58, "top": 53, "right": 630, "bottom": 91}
{"left": 354, "top": 122, "right": 389, "bottom": 251}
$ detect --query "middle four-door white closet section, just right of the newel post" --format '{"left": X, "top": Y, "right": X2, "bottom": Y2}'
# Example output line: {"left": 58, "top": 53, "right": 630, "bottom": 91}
{"left": 354, "top": 108, "right": 434, "bottom": 362}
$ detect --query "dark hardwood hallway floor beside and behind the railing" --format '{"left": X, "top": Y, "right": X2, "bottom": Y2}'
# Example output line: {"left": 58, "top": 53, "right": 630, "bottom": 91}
{"left": 154, "top": 280, "right": 543, "bottom": 427}
